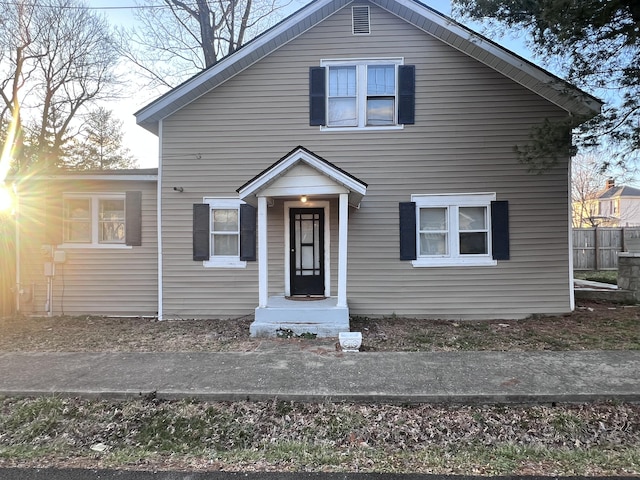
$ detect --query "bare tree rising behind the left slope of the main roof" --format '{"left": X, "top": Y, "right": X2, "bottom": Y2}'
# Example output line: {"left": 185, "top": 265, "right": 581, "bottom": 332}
{"left": 120, "top": 0, "right": 291, "bottom": 89}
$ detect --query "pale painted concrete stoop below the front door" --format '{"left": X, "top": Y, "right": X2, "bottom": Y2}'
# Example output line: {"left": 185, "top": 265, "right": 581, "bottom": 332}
{"left": 249, "top": 297, "right": 349, "bottom": 337}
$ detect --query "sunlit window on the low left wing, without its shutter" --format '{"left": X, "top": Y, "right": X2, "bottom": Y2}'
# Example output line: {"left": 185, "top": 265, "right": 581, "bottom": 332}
{"left": 62, "top": 194, "right": 126, "bottom": 246}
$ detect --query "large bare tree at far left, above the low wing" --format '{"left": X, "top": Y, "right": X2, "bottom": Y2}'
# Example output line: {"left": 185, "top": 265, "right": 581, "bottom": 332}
{"left": 0, "top": 0, "right": 118, "bottom": 171}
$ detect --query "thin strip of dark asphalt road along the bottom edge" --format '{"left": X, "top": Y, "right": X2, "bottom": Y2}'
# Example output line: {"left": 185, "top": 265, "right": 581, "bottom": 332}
{"left": 0, "top": 468, "right": 638, "bottom": 480}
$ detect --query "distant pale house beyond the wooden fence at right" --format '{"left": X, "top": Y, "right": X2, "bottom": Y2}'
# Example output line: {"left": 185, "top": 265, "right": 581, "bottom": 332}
{"left": 573, "top": 179, "right": 640, "bottom": 227}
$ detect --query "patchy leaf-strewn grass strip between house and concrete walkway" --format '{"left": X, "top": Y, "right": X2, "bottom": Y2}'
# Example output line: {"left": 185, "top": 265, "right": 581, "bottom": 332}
{"left": 0, "top": 302, "right": 640, "bottom": 352}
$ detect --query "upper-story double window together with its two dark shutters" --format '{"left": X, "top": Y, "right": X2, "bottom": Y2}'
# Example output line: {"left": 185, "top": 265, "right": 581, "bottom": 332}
{"left": 310, "top": 59, "right": 415, "bottom": 130}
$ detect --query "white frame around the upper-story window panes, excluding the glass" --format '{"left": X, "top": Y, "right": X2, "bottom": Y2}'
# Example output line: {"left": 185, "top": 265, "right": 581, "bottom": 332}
{"left": 320, "top": 58, "right": 404, "bottom": 132}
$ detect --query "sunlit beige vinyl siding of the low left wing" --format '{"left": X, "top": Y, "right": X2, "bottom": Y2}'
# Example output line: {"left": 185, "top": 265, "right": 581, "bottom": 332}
{"left": 19, "top": 178, "right": 158, "bottom": 316}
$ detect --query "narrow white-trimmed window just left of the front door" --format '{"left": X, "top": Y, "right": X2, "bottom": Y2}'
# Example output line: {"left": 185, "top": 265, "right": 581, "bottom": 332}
{"left": 204, "top": 198, "right": 247, "bottom": 268}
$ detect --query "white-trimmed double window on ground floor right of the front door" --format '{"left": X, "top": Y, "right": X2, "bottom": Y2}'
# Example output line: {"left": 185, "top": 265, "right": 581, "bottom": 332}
{"left": 411, "top": 193, "right": 497, "bottom": 267}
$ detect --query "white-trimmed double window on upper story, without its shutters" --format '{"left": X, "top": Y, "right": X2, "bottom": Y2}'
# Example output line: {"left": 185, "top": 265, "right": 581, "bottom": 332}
{"left": 322, "top": 59, "right": 402, "bottom": 128}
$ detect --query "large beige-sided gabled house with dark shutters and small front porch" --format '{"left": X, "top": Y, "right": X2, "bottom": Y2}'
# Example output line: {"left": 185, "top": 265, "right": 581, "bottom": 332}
{"left": 10, "top": 0, "right": 601, "bottom": 335}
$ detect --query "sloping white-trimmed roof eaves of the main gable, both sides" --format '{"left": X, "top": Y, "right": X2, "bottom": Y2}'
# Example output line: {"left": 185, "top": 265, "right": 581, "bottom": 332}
{"left": 135, "top": 0, "right": 602, "bottom": 134}
